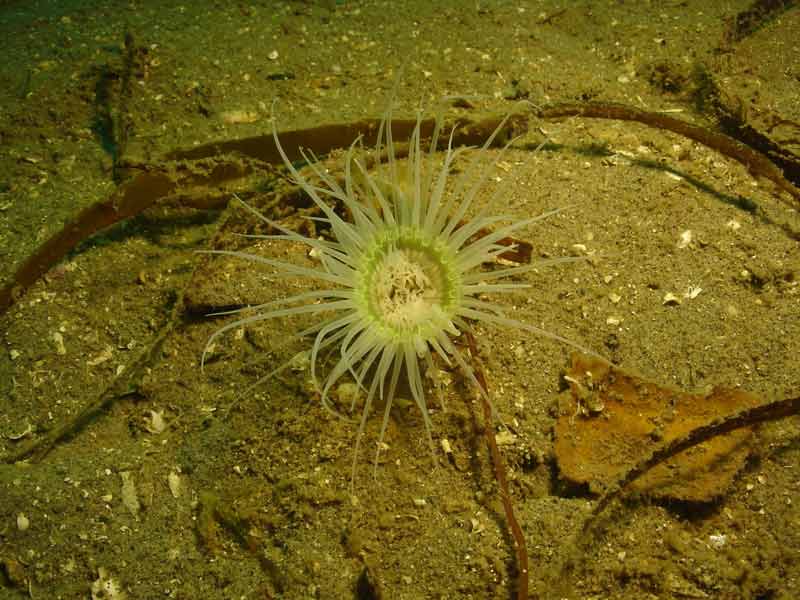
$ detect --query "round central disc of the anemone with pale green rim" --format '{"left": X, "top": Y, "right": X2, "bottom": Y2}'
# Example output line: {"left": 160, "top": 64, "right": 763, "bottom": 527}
{"left": 356, "top": 227, "right": 461, "bottom": 350}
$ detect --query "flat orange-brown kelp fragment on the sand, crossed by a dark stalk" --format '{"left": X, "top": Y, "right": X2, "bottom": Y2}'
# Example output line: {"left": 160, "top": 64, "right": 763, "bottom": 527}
{"left": 555, "top": 354, "right": 763, "bottom": 502}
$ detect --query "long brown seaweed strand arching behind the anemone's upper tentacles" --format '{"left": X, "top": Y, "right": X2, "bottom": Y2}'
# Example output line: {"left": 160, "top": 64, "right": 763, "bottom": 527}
{"left": 0, "top": 102, "right": 800, "bottom": 314}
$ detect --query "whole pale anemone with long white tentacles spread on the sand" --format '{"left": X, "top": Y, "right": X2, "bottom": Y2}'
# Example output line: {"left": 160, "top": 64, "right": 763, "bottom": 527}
{"left": 203, "top": 98, "right": 576, "bottom": 482}
